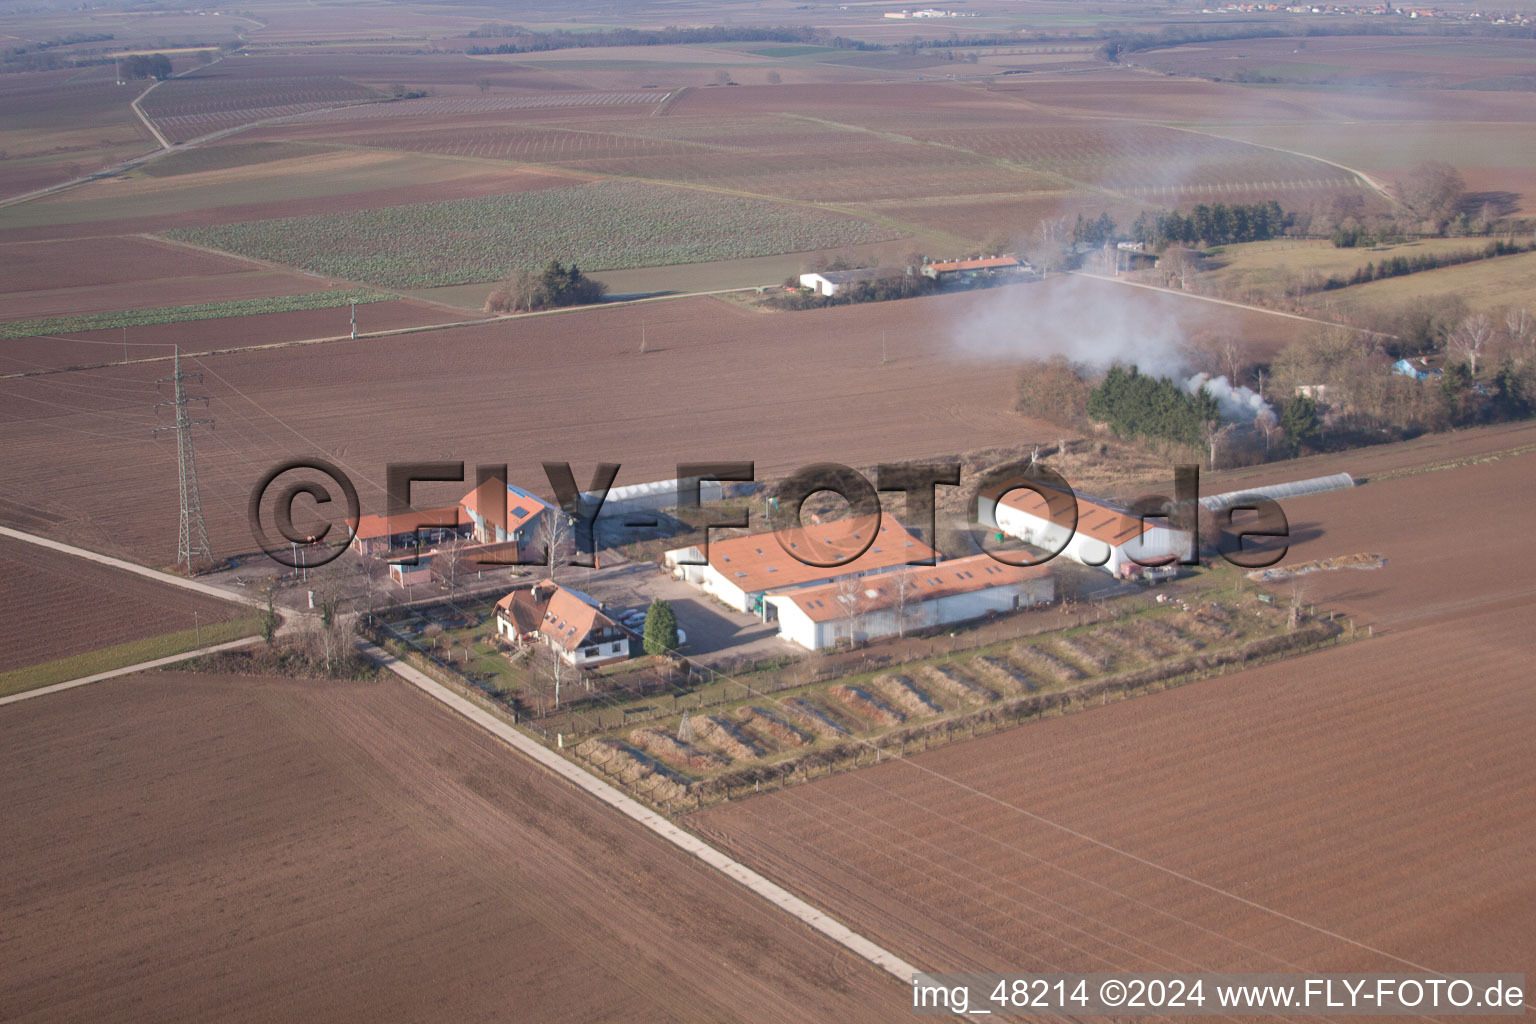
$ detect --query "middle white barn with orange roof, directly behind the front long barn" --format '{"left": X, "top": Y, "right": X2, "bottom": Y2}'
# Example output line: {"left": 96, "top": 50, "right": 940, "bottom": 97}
{"left": 662, "top": 516, "right": 934, "bottom": 622}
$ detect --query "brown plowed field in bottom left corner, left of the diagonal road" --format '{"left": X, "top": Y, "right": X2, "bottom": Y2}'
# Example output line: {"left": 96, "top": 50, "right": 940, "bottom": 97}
{"left": 0, "top": 674, "right": 905, "bottom": 1021}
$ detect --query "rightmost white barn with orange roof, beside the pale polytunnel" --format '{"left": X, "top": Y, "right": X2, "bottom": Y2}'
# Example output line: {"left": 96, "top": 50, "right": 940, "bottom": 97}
{"left": 977, "top": 488, "right": 1190, "bottom": 576}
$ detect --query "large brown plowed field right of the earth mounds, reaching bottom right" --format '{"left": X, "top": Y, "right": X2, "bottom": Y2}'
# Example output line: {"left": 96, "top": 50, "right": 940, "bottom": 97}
{"left": 693, "top": 454, "right": 1536, "bottom": 972}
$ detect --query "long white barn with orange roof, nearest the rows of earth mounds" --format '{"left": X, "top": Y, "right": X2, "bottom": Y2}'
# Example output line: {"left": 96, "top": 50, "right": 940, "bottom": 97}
{"left": 765, "top": 554, "right": 1055, "bottom": 651}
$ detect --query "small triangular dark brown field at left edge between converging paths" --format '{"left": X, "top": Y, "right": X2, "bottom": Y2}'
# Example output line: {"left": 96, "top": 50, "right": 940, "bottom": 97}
{"left": 0, "top": 537, "right": 246, "bottom": 672}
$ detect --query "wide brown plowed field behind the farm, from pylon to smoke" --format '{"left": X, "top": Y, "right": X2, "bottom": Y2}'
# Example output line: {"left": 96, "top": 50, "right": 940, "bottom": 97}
{"left": 0, "top": 279, "right": 1295, "bottom": 562}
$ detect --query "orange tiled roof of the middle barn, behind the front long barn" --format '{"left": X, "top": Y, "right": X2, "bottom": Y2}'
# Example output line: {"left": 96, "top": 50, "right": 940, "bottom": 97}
{"left": 710, "top": 516, "right": 934, "bottom": 594}
